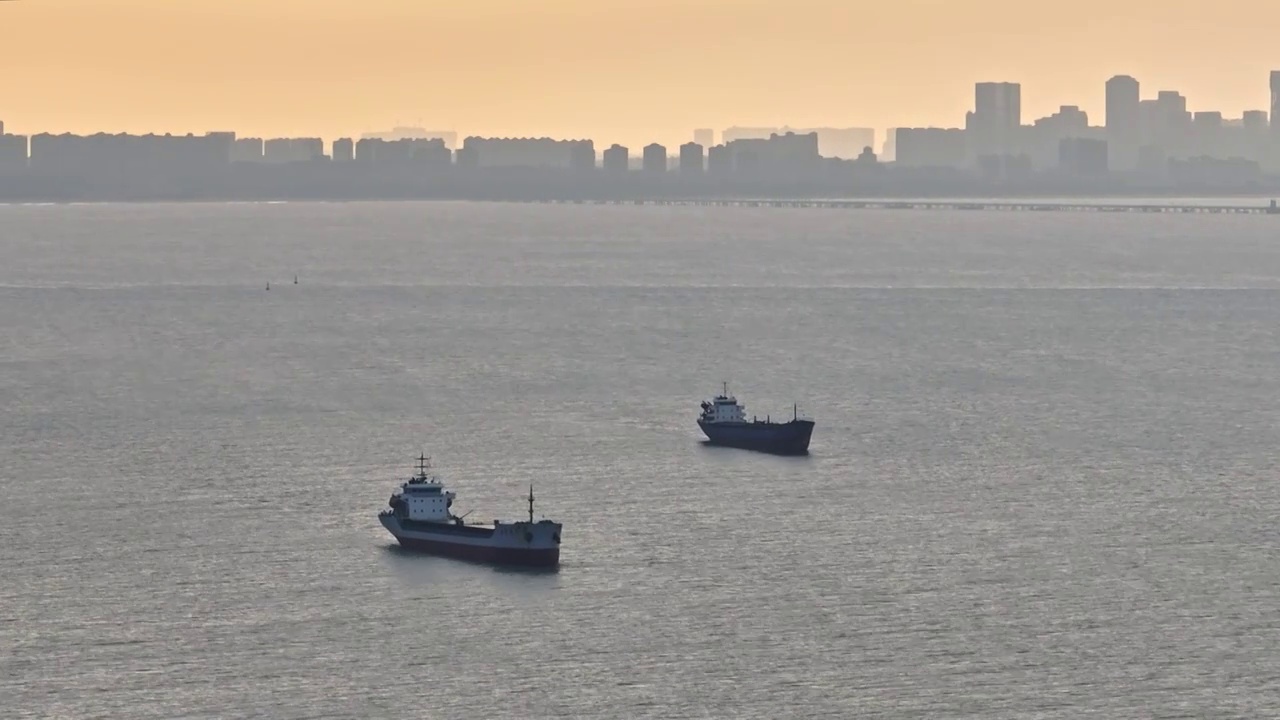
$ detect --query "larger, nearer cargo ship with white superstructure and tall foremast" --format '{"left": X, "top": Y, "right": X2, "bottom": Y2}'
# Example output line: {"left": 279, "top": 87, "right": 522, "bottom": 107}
{"left": 378, "top": 455, "right": 561, "bottom": 568}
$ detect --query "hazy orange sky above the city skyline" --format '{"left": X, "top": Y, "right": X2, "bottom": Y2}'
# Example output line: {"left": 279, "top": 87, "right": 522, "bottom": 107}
{"left": 0, "top": 0, "right": 1280, "bottom": 146}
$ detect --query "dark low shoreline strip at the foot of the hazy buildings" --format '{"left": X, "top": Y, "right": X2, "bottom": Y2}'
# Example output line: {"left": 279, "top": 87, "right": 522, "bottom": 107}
{"left": 0, "top": 161, "right": 1280, "bottom": 204}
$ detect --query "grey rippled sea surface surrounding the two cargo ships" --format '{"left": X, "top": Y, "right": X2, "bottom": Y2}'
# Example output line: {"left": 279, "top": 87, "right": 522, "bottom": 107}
{"left": 0, "top": 198, "right": 1280, "bottom": 719}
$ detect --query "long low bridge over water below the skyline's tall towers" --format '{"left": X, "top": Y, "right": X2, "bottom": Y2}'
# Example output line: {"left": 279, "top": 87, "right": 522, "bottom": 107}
{"left": 545, "top": 199, "right": 1280, "bottom": 215}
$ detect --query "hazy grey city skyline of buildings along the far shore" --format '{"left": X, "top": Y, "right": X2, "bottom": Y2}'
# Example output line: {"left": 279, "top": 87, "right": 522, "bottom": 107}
{"left": 0, "top": 70, "right": 1280, "bottom": 201}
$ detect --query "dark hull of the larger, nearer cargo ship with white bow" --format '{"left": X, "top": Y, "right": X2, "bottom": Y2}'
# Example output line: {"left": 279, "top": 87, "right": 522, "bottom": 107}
{"left": 379, "top": 512, "right": 561, "bottom": 568}
